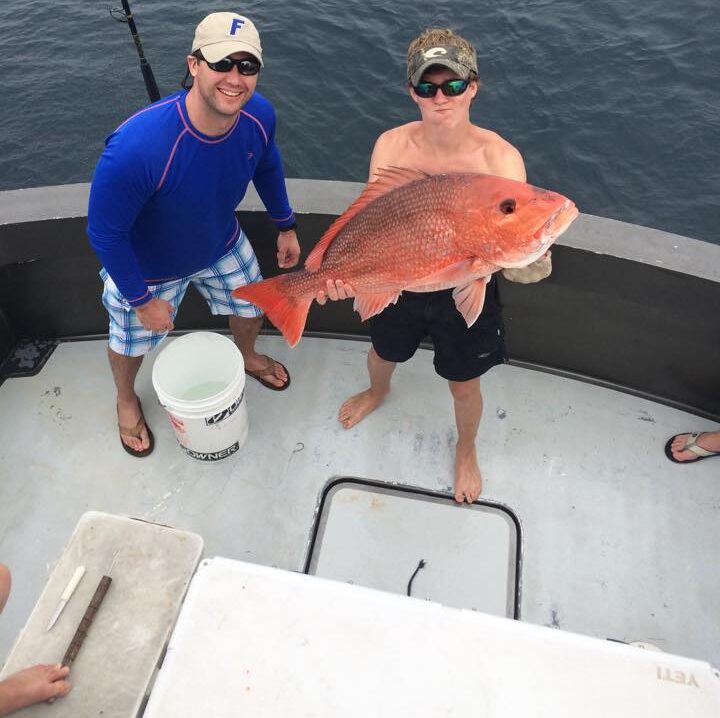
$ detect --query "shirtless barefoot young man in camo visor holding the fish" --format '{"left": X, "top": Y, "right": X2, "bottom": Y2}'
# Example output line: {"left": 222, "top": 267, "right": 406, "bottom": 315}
{"left": 318, "top": 29, "right": 540, "bottom": 503}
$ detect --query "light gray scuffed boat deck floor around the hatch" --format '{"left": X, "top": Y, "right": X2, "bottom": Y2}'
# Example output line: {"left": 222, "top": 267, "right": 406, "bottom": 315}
{"left": 0, "top": 336, "right": 720, "bottom": 666}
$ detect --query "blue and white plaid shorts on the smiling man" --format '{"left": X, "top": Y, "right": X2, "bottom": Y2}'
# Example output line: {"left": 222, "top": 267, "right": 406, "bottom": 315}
{"left": 100, "top": 231, "right": 262, "bottom": 357}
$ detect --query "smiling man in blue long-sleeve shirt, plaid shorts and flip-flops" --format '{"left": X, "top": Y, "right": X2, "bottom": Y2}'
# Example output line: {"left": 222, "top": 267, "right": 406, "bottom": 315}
{"left": 88, "top": 12, "right": 300, "bottom": 456}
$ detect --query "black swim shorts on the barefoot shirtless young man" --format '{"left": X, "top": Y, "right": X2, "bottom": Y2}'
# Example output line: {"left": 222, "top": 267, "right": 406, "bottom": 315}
{"left": 368, "top": 276, "right": 507, "bottom": 381}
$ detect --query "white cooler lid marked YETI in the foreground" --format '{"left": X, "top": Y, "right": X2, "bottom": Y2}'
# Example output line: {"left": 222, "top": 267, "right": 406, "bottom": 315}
{"left": 144, "top": 558, "right": 720, "bottom": 718}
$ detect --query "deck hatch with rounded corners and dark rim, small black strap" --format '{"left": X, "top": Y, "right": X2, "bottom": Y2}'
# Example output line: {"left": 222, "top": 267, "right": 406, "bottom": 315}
{"left": 305, "top": 478, "right": 521, "bottom": 618}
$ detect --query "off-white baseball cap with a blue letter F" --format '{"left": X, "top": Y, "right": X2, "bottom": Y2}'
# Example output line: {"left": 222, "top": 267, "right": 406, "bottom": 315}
{"left": 191, "top": 12, "right": 263, "bottom": 65}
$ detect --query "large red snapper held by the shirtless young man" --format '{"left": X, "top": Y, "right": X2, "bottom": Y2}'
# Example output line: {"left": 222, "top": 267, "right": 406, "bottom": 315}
{"left": 233, "top": 168, "right": 578, "bottom": 347}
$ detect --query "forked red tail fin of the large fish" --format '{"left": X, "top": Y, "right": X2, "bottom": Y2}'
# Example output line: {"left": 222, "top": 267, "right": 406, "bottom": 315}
{"left": 233, "top": 275, "right": 314, "bottom": 347}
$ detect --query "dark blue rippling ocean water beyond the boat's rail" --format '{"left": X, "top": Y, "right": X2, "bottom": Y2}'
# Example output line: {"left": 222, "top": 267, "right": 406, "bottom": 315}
{"left": 0, "top": 0, "right": 720, "bottom": 243}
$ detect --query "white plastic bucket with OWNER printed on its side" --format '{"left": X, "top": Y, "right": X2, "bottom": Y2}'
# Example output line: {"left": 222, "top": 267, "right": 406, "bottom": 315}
{"left": 152, "top": 332, "right": 248, "bottom": 461}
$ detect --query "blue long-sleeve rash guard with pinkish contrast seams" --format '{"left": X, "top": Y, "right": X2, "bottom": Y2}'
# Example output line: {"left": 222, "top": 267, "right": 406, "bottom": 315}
{"left": 88, "top": 91, "right": 295, "bottom": 306}
